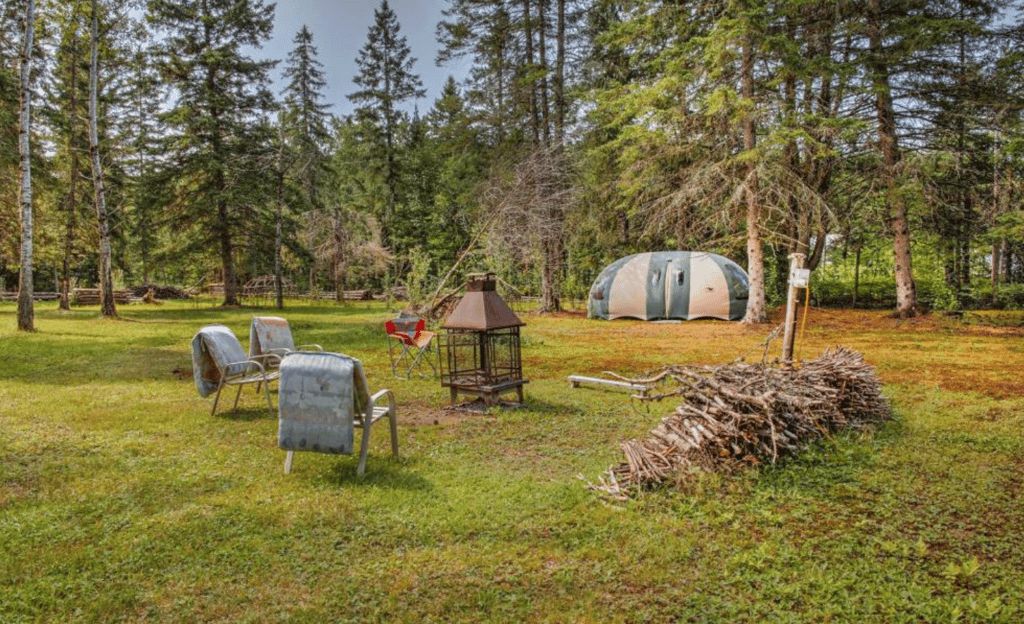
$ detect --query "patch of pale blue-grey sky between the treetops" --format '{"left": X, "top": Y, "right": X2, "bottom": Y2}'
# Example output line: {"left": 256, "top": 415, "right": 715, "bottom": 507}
{"left": 253, "top": 0, "right": 469, "bottom": 117}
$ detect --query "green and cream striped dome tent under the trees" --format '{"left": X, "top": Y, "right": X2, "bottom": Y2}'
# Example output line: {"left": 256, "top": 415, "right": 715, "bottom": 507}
{"left": 587, "top": 251, "right": 750, "bottom": 321}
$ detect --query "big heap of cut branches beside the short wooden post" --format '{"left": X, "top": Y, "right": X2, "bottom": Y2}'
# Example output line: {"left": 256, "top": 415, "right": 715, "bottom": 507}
{"left": 589, "top": 347, "right": 892, "bottom": 500}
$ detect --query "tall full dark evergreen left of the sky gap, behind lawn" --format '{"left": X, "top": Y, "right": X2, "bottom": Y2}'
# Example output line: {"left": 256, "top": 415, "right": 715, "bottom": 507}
{"left": 147, "top": 0, "right": 274, "bottom": 305}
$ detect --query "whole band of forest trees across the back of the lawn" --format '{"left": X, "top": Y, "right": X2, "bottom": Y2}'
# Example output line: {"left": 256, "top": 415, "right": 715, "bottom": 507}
{"left": 0, "top": 0, "right": 1024, "bottom": 329}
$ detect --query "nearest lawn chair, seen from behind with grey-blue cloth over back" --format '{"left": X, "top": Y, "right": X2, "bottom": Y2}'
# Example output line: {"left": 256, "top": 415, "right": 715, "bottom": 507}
{"left": 278, "top": 351, "right": 398, "bottom": 474}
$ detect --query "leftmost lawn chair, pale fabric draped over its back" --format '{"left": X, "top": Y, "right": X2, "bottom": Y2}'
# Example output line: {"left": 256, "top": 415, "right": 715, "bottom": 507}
{"left": 191, "top": 324, "right": 281, "bottom": 416}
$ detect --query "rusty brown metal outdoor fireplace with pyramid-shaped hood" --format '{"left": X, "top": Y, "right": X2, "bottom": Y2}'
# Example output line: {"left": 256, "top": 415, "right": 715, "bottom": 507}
{"left": 441, "top": 274, "right": 527, "bottom": 406}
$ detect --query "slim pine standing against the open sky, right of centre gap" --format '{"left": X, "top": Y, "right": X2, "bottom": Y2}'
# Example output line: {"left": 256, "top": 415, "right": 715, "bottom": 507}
{"left": 348, "top": 0, "right": 426, "bottom": 246}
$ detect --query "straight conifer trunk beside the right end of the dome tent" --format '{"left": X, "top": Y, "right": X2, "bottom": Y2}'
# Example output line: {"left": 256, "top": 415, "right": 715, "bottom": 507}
{"left": 740, "top": 35, "right": 768, "bottom": 325}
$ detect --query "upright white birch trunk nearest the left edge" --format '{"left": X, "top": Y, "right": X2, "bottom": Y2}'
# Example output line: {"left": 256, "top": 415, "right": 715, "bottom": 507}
{"left": 17, "top": 0, "right": 36, "bottom": 332}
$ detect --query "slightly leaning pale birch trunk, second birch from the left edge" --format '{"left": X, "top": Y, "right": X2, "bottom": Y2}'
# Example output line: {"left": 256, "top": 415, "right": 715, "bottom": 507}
{"left": 89, "top": 0, "right": 118, "bottom": 317}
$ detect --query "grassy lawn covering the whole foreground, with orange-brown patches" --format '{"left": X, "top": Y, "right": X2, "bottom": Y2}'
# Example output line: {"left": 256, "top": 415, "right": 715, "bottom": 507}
{"left": 0, "top": 302, "right": 1024, "bottom": 624}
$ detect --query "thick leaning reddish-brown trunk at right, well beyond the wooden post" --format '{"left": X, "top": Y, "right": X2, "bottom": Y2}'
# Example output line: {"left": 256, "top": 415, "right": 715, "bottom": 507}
{"left": 869, "top": 0, "right": 918, "bottom": 319}
